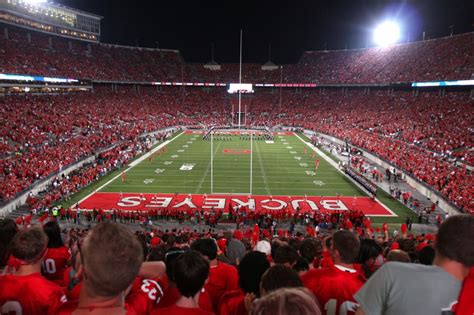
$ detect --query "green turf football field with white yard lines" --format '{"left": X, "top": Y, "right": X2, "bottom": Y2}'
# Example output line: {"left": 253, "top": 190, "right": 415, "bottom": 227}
{"left": 99, "top": 133, "right": 365, "bottom": 196}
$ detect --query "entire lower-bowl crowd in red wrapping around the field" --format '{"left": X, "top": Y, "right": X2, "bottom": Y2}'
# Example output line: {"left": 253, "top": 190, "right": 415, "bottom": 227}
{"left": 0, "top": 87, "right": 474, "bottom": 215}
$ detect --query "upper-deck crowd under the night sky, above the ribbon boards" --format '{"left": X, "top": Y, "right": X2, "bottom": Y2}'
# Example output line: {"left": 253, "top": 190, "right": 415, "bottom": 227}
{"left": 0, "top": 27, "right": 474, "bottom": 84}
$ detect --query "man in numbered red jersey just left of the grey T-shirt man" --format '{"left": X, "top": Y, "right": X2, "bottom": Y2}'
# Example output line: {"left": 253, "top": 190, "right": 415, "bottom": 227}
{"left": 302, "top": 230, "right": 365, "bottom": 315}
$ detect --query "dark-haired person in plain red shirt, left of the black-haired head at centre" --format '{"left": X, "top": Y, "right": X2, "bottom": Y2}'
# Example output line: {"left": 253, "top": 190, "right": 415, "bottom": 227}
{"left": 191, "top": 238, "right": 239, "bottom": 311}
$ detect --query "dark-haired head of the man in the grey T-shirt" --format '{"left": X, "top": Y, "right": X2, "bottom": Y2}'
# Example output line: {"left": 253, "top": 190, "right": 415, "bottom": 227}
{"left": 435, "top": 214, "right": 474, "bottom": 267}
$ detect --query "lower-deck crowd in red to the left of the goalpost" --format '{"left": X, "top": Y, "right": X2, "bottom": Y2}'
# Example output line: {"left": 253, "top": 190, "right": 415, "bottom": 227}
{"left": 0, "top": 88, "right": 227, "bottom": 201}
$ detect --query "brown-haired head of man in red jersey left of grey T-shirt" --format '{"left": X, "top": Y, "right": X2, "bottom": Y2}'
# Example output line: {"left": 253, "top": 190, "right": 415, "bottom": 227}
{"left": 331, "top": 230, "right": 361, "bottom": 264}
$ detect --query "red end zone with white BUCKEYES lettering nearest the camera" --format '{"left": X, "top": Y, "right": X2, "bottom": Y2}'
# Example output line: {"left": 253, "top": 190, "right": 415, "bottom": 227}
{"left": 79, "top": 192, "right": 397, "bottom": 217}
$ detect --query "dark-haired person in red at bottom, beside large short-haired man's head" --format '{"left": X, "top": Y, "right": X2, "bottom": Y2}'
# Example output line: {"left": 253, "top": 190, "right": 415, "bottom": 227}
{"left": 151, "top": 251, "right": 212, "bottom": 315}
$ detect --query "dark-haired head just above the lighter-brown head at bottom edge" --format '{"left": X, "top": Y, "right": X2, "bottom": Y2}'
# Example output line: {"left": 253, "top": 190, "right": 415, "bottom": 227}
{"left": 260, "top": 265, "right": 303, "bottom": 294}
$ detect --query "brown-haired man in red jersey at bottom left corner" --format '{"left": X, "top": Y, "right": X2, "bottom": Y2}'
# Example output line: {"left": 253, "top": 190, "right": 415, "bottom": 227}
{"left": 0, "top": 227, "right": 66, "bottom": 314}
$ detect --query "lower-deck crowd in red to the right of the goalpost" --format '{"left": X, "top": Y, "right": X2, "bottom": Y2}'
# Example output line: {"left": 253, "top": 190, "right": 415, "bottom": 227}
{"left": 247, "top": 90, "right": 474, "bottom": 212}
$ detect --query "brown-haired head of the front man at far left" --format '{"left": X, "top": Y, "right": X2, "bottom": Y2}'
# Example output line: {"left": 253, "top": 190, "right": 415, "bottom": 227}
{"left": 10, "top": 227, "right": 48, "bottom": 265}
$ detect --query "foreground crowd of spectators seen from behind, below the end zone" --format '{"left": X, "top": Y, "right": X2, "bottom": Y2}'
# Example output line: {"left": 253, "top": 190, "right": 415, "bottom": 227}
{"left": 0, "top": 215, "right": 474, "bottom": 315}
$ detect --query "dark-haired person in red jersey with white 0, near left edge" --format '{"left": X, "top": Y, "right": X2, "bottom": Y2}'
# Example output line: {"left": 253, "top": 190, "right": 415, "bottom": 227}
{"left": 42, "top": 221, "right": 71, "bottom": 286}
